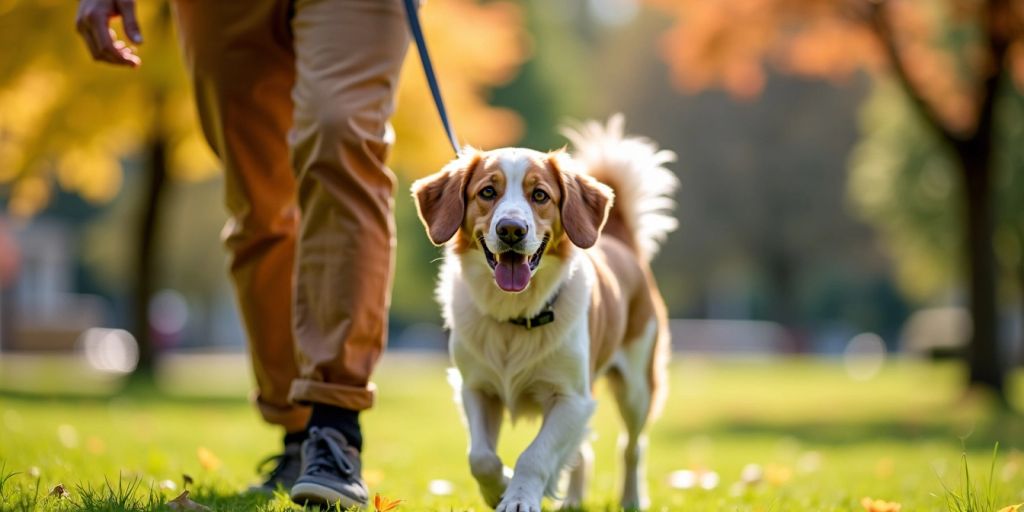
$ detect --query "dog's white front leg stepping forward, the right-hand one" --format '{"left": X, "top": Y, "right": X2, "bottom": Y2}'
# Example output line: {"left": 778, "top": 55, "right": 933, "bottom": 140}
{"left": 497, "top": 394, "right": 594, "bottom": 512}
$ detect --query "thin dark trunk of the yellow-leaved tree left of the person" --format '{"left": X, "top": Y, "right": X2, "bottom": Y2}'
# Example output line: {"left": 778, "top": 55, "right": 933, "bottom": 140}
{"left": 132, "top": 128, "right": 167, "bottom": 382}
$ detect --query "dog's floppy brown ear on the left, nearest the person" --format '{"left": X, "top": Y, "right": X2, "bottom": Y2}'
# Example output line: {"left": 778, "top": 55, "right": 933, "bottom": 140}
{"left": 413, "top": 150, "right": 480, "bottom": 246}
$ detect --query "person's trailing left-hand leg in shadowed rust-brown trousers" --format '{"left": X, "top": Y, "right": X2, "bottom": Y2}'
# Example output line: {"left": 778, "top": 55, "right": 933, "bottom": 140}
{"left": 173, "top": 0, "right": 309, "bottom": 452}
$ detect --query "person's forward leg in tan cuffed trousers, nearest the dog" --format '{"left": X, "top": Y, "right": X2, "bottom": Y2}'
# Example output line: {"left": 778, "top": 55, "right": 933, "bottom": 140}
{"left": 291, "top": 0, "right": 409, "bottom": 506}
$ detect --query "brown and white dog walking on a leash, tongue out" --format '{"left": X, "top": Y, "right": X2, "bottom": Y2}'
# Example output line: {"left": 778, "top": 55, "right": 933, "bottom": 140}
{"left": 413, "top": 116, "right": 677, "bottom": 512}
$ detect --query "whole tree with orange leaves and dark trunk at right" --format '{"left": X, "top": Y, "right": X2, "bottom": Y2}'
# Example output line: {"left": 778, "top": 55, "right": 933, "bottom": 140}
{"left": 648, "top": 0, "right": 1024, "bottom": 400}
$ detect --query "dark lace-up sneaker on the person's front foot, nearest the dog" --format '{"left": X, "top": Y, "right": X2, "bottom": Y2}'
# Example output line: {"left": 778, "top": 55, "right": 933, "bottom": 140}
{"left": 292, "top": 427, "right": 369, "bottom": 509}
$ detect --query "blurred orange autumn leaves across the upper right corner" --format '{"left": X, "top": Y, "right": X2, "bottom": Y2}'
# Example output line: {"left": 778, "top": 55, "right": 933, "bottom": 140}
{"left": 646, "top": 0, "right": 1024, "bottom": 132}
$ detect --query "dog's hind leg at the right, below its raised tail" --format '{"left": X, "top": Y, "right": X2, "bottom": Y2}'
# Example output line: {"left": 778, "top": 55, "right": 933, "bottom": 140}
{"left": 608, "top": 329, "right": 656, "bottom": 510}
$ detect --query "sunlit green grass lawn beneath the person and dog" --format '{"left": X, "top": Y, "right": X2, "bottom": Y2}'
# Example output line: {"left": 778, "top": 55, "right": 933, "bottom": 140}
{"left": 0, "top": 354, "right": 1024, "bottom": 511}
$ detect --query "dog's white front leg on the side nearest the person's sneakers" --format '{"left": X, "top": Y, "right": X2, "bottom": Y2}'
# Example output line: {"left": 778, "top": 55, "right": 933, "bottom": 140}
{"left": 462, "top": 387, "right": 511, "bottom": 508}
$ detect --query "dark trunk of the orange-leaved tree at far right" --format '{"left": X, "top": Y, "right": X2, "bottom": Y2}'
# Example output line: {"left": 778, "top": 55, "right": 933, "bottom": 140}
{"left": 961, "top": 149, "right": 1007, "bottom": 402}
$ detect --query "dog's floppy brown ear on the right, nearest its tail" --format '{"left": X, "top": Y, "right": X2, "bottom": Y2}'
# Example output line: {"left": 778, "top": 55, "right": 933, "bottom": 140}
{"left": 549, "top": 152, "right": 614, "bottom": 249}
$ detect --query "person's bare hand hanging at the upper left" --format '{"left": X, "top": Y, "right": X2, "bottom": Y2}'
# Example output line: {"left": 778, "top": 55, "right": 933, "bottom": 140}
{"left": 75, "top": 0, "right": 142, "bottom": 68}
